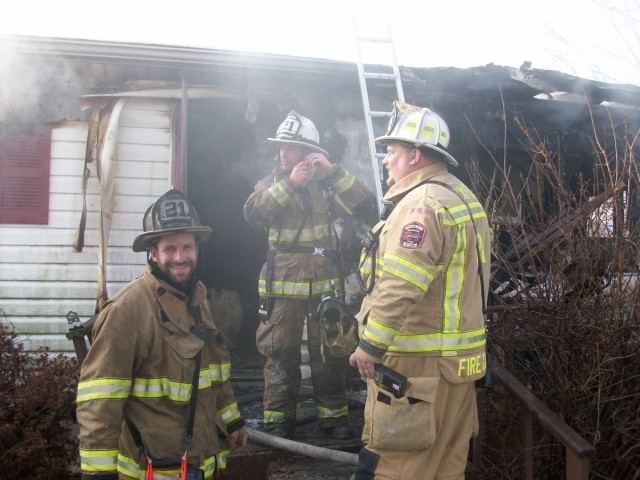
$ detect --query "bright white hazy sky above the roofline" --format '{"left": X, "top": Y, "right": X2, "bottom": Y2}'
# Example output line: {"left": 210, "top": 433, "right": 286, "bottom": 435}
{"left": 0, "top": 0, "right": 640, "bottom": 85}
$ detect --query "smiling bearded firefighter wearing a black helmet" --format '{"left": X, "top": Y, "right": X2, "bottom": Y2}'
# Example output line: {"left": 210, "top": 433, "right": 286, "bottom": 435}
{"left": 77, "top": 189, "right": 247, "bottom": 480}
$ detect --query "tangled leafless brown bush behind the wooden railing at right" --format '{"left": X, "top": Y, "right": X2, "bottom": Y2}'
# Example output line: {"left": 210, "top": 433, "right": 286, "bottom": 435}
{"left": 482, "top": 109, "right": 640, "bottom": 479}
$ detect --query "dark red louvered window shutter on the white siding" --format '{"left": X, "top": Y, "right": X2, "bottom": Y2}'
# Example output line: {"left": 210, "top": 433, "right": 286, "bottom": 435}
{"left": 0, "top": 125, "right": 51, "bottom": 225}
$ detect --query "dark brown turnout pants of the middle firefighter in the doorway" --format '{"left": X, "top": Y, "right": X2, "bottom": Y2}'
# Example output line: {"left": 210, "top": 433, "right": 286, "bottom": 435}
{"left": 256, "top": 297, "right": 348, "bottom": 428}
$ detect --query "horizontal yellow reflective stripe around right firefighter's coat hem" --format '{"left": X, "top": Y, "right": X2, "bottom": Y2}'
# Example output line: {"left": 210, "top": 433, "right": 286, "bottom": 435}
{"left": 388, "top": 325, "right": 487, "bottom": 355}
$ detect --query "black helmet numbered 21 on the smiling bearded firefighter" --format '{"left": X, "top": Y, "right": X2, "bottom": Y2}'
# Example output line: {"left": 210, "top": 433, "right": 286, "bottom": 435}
{"left": 133, "top": 189, "right": 211, "bottom": 252}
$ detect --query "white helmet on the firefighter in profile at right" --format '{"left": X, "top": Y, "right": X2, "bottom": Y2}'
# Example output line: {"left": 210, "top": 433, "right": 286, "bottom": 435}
{"left": 375, "top": 100, "right": 458, "bottom": 167}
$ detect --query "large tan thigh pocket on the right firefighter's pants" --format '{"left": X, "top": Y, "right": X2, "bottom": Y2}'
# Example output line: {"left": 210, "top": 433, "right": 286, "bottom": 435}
{"left": 369, "top": 377, "right": 440, "bottom": 451}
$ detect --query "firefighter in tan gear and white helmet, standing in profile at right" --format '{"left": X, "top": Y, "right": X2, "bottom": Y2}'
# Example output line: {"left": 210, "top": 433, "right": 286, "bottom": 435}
{"left": 350, "top": 102, "right": 490, "bottom": 480}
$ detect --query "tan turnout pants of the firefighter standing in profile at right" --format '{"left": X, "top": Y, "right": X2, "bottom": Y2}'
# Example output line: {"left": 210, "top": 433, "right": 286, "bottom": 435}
{"left": 355, "top": 356, "right": 478, "bottom": 480}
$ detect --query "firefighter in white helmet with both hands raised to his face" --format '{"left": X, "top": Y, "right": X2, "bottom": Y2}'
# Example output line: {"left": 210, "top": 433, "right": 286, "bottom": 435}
{"left": 244, "top": 111, "right": 373, "bottom": 439}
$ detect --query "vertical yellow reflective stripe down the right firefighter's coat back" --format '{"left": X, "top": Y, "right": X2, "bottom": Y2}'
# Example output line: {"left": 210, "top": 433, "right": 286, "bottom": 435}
{"left": 442, "top": 225, "right": 467, "bottom": 332}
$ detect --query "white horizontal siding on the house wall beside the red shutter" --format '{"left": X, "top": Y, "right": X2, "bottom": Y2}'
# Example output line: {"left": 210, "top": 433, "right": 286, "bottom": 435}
{"left": 0, "top": 99, "right": 173, "bottom": 352}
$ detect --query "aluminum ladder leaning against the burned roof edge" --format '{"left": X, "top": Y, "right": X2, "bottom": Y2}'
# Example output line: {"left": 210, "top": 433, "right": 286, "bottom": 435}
{"left": 353, "top": 18, "right": 404, "bottom": 218}
